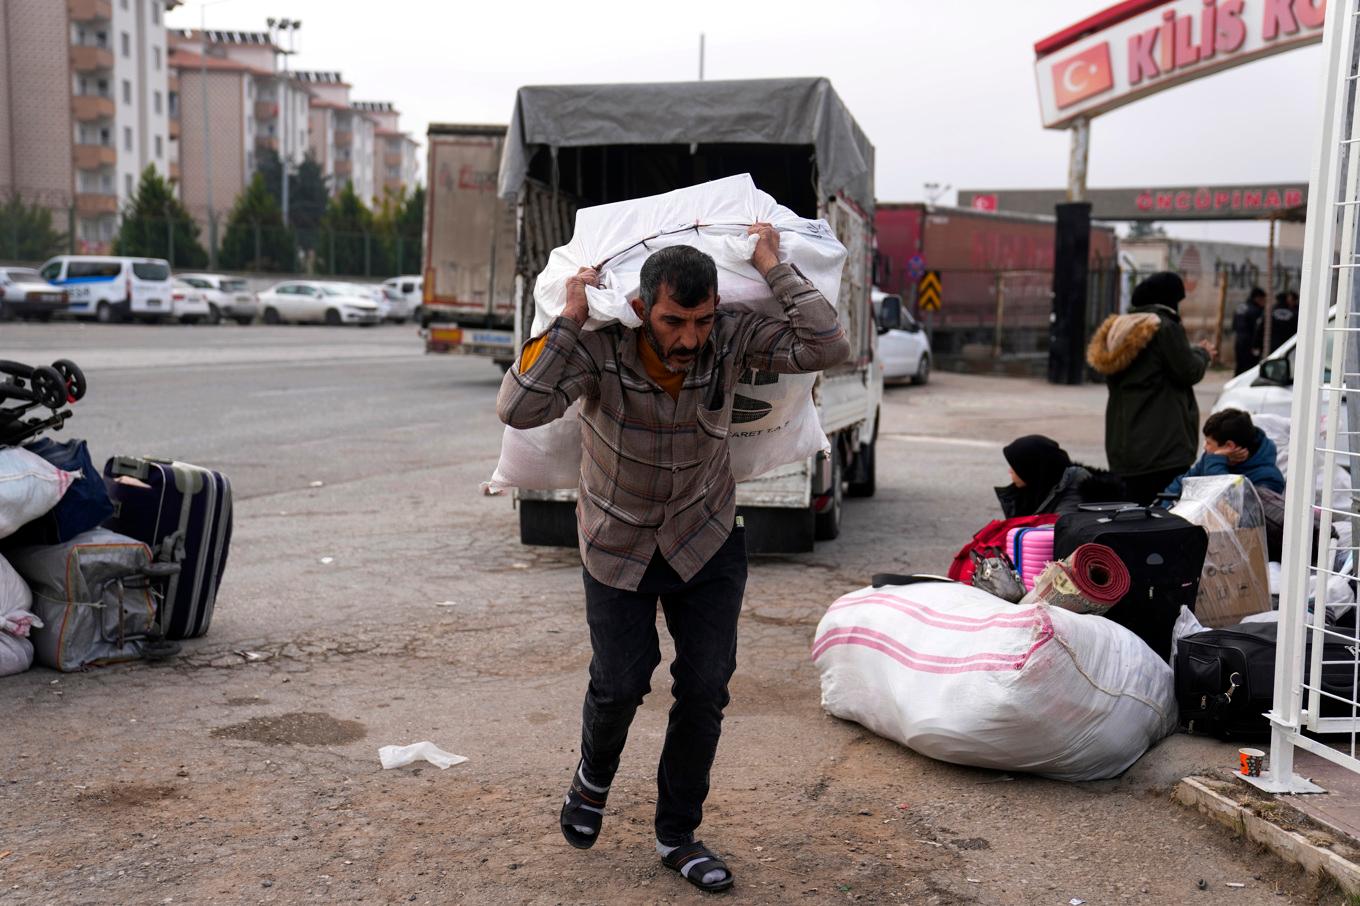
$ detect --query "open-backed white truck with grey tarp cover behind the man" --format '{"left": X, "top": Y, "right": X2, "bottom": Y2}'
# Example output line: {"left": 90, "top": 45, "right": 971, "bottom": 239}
{"left": 500, "top": 78, "right": 883, "bottom": 552}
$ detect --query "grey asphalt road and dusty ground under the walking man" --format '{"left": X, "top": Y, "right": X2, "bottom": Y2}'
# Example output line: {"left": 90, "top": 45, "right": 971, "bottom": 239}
{"left": 0, "top": 324, "right": 1331, "bottom": 905}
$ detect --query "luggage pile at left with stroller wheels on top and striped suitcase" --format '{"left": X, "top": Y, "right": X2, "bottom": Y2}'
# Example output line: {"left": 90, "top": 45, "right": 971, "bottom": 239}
{"left": 0, "top": 360, "right": 231, "bottom": 676}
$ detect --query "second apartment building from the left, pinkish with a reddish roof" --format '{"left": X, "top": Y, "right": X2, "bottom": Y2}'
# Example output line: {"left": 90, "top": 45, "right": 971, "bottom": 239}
{"left": 170, "top": 30, "right": 310, "bottom": 231}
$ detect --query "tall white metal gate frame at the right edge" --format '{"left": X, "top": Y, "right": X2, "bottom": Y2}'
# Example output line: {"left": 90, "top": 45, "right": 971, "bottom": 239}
{"left": 1257, "top": 0, "right": 1360, "bottom": 793}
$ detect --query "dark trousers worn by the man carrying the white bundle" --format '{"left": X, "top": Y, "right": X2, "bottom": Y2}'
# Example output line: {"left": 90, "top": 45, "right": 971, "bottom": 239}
{"left": 581, "top": 528, "right": 747, "bottom": 845}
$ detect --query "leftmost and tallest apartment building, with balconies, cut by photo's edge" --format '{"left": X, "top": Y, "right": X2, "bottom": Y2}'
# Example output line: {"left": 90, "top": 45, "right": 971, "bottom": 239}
{"left": 0, "top": 0, "right": 180, "bottom": 252}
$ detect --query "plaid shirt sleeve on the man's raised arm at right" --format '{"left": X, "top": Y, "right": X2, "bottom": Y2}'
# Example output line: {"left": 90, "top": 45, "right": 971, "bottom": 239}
{"left": 745, "top": 264, "right": 850, "bottom": 374}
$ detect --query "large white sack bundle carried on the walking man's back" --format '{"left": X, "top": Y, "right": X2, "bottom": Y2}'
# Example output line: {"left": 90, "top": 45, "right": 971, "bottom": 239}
{"left": 486, "top": 174, "right": 847, "bottom": 494}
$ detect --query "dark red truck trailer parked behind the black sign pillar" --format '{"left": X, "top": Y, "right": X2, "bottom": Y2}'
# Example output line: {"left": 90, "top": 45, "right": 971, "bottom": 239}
{"left": 874, "top": 201, "right": 1119, "bottom": 365}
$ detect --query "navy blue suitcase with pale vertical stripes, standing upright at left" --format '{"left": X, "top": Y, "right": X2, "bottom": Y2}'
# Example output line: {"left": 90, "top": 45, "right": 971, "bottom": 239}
{"left": 103, "top": 456, "right": 231, "bottom": 639}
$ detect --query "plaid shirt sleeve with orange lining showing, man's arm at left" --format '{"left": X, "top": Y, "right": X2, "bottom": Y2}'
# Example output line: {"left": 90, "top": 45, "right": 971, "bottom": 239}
{"left": 496, "top": 317, "right": 600, "bottom": 429}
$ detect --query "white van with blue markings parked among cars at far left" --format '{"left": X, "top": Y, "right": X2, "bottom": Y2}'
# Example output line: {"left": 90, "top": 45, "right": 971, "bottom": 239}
{"left": 39, "top": 254, "right": 174, "bottom": 322}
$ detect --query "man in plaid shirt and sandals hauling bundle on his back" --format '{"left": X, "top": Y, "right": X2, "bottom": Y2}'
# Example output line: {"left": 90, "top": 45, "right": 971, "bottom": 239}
{"left": 496, "top": 223, "right": 850, "bottom": 891}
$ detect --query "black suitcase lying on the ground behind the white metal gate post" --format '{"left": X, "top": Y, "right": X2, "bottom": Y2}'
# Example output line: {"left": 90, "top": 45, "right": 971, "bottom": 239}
{"left": 1175, "top": 623, "right": 1360, "bottom": 741}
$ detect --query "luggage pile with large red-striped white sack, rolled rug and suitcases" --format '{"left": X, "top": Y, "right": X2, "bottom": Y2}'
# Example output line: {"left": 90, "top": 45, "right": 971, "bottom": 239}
{"left": 812, "top": 476, "right": 1316, "bottom": 781}
